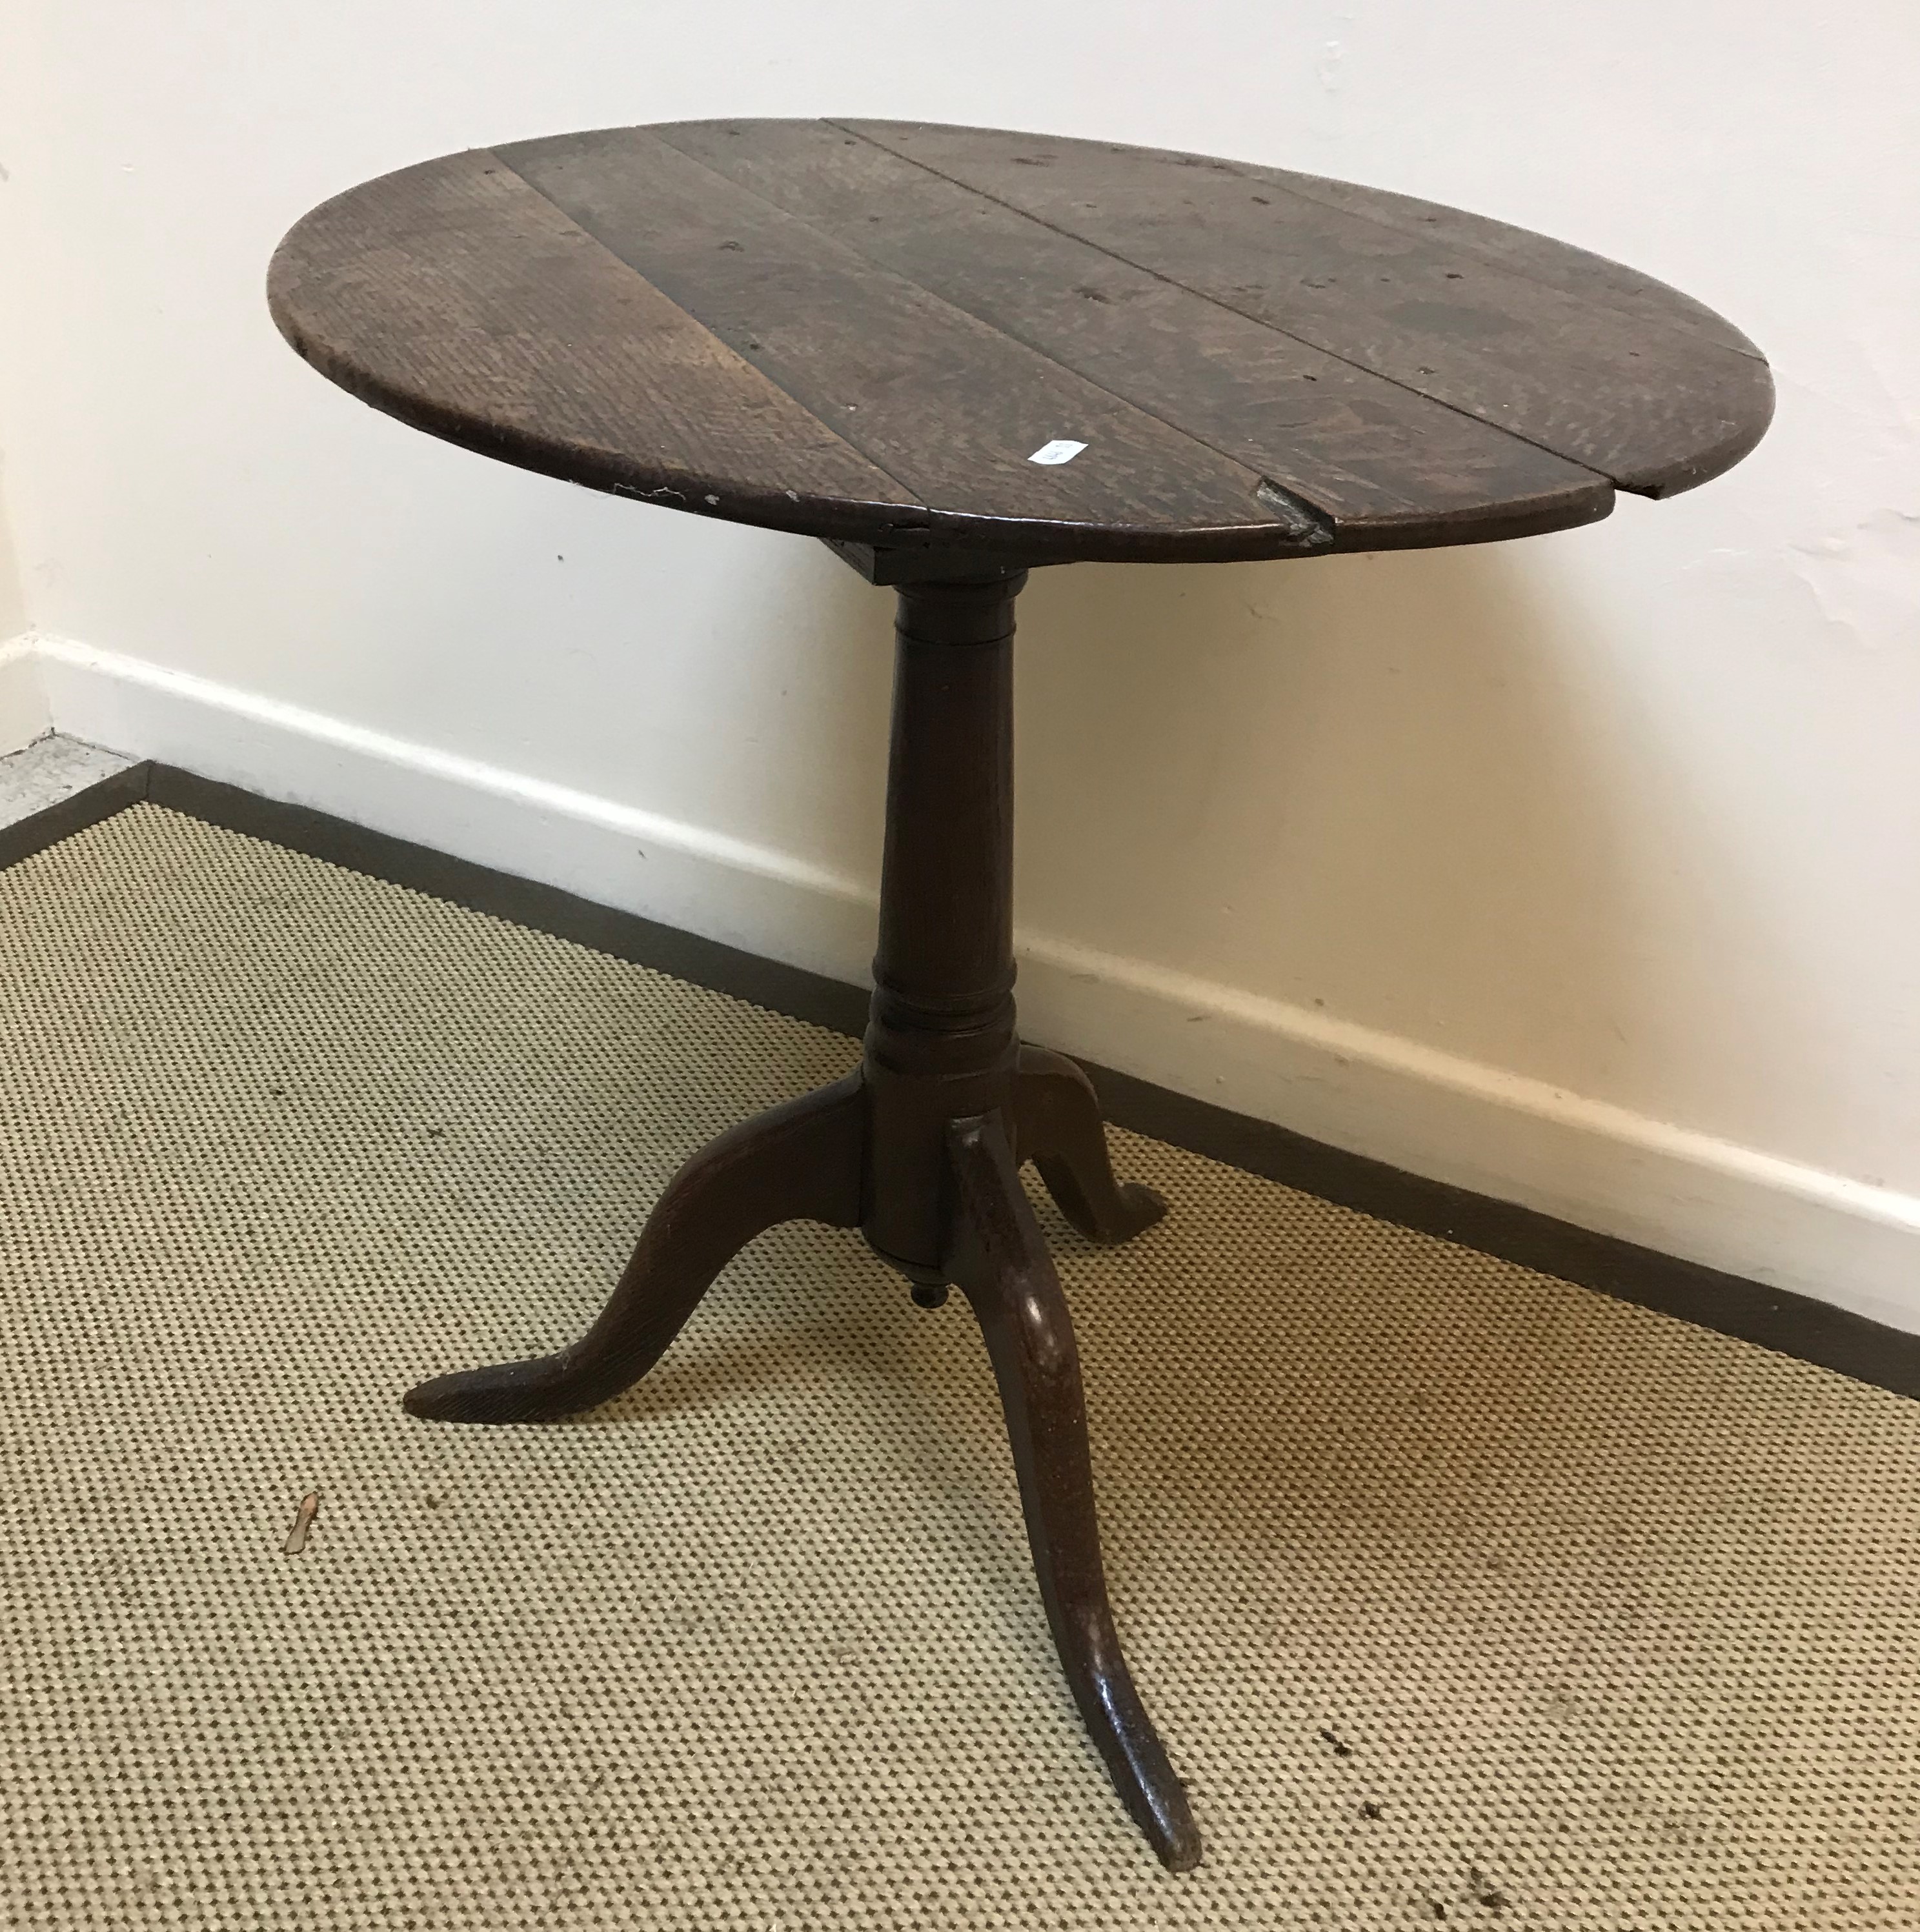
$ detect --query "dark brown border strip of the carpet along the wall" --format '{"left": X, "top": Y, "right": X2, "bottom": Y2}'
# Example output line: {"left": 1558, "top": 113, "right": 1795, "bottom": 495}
{"left": 0, "top": 763, "right": 1920, "bottom": 1397}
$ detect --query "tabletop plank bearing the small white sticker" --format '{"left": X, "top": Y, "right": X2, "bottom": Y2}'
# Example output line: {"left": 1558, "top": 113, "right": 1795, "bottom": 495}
{"left": 487, "top": 128, "right": 1298, "bottom": 550}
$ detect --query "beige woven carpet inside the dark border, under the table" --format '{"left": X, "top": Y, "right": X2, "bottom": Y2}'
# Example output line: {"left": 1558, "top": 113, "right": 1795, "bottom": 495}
{"left": 0, "top": 805, "right": 1920, "bottom": 1932}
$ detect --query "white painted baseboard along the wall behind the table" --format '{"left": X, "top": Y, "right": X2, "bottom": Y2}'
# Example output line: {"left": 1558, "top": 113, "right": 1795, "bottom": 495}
{"left": 15, "top": 636, "right": 1920, "bottom": 1333}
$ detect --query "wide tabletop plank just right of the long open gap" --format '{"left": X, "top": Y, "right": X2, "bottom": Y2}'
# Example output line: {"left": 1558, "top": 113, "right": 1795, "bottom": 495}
{"left": 846, "top": 122, "right": 1773, "bottom": 496}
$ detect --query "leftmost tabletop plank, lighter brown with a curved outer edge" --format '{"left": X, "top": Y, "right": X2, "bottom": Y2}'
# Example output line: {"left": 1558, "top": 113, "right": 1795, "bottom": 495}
{"left": 267, "top": 149, "right": 925, "bottom": 537}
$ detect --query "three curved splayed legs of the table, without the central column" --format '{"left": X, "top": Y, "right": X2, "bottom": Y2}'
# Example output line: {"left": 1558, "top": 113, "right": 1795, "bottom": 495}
{"left": 406, "top": 1047, "right": 1200, "bottom": 1870}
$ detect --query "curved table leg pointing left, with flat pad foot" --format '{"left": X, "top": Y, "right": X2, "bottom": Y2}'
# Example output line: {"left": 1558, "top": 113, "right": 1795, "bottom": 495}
{"left": 406, "top": 1074, "right": 865, "bottom": 1422}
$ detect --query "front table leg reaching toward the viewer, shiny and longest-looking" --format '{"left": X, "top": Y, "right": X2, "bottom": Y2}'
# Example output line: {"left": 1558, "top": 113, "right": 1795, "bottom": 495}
{"left": 949, "top": 1120, "right": 1200, "bottom": 1872}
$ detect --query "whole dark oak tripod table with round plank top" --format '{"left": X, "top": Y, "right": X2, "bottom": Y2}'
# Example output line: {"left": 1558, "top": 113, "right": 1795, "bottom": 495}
{"left": 270, "top": 120, "right": 1773, "bottom": 1868}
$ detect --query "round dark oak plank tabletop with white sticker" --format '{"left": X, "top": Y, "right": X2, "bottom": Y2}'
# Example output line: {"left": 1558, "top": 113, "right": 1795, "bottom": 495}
{"left": 268, "top": 120, "right": 1773, "bottom": 562}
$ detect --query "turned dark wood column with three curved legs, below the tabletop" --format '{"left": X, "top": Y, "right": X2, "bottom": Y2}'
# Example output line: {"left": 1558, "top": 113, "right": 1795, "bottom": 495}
{"left": 406, "top": 558, "right": 1200, "bottom": 1870}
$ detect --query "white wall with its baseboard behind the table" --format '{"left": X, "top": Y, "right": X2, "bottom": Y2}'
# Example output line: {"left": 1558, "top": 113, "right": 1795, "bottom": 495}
{"left": 0, "top": 0, "right": 1920, "bottom": 1327}
